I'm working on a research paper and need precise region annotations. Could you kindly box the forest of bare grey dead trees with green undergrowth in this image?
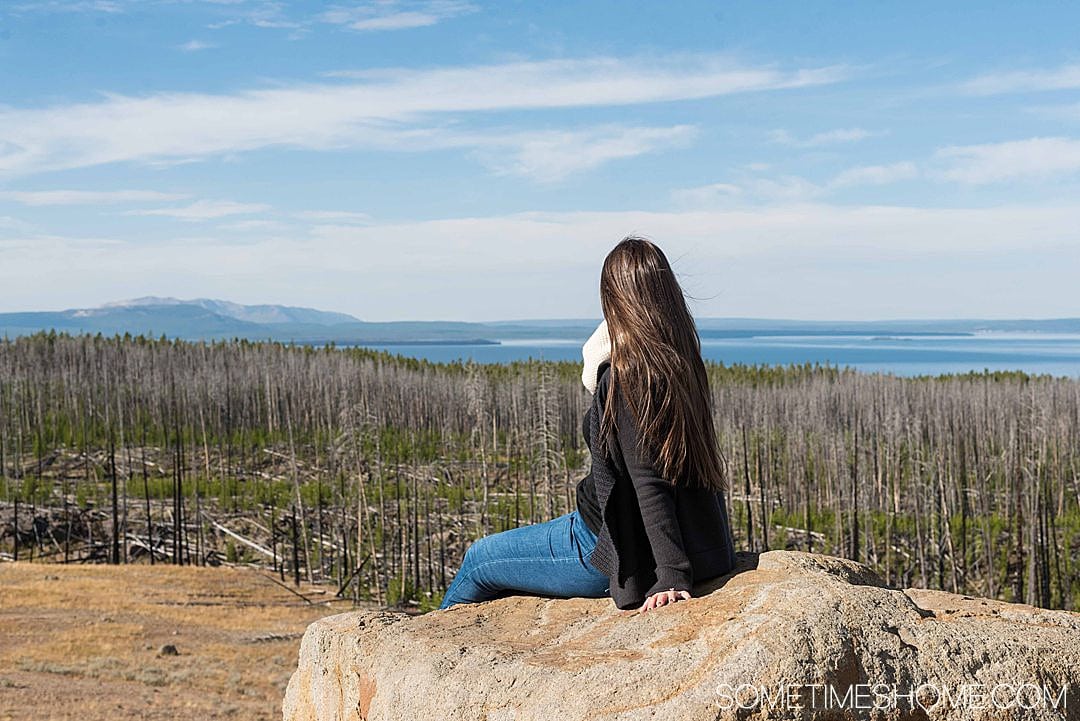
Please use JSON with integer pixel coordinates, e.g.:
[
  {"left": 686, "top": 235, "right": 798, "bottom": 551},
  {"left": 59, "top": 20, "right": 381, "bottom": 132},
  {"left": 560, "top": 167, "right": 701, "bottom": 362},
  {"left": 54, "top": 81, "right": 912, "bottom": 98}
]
[{"left": 0, "top": 332, "right": 1080, "bottom": 612}]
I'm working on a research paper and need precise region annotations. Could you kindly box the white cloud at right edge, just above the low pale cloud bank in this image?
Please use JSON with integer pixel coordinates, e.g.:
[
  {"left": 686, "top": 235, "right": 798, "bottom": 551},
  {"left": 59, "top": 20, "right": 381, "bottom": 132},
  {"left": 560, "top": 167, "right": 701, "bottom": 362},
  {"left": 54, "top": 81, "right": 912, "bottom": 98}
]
[{"left": 935, "top": 137, "right": 1080, "bottom": 185}]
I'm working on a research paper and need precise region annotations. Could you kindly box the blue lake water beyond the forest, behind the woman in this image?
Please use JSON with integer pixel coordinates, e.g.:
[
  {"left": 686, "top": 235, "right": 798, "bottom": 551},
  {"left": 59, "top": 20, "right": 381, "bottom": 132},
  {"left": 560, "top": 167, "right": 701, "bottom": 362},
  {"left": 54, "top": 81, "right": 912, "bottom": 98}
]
[{"left": 358, "top": 332, "right": 1080, "bottom": 378}]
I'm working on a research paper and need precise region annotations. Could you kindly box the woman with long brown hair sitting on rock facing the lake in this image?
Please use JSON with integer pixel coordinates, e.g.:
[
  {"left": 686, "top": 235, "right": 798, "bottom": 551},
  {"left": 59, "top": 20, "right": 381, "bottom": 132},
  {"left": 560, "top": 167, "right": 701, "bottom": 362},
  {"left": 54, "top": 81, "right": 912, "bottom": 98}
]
[{"left": 440, "top": 237, "right": 734, "bottom": 611}]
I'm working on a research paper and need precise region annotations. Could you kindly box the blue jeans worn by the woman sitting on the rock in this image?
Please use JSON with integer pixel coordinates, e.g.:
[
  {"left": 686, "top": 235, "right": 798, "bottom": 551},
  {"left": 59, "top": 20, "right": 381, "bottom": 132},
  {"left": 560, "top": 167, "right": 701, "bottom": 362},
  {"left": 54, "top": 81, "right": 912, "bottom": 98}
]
[{"left": 438, "top": 511, "right": 608, "bottom": 609}]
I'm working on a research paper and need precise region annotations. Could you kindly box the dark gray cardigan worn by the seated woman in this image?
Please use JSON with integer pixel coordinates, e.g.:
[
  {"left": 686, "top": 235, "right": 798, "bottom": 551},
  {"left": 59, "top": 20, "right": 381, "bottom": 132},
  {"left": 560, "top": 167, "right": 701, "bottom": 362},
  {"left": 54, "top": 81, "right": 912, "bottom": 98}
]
[{"left": 589, "top": 361, "right": 735, "bottom": 609}]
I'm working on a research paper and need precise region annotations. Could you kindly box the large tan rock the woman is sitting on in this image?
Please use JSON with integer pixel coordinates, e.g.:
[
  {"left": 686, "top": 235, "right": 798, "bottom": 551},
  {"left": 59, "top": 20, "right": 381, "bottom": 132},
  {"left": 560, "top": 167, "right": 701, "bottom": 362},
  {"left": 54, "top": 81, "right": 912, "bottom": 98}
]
[{"left": 283, "top": 550, "right": 1080, "bottom": 721}]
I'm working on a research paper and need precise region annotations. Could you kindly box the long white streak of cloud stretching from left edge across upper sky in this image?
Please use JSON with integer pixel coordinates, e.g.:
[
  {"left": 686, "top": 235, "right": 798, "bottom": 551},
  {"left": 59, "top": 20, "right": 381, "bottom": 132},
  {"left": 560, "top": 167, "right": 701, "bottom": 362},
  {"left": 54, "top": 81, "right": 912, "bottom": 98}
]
[{"left": 0, "top": 56, "right": 846, "bottom": 174}]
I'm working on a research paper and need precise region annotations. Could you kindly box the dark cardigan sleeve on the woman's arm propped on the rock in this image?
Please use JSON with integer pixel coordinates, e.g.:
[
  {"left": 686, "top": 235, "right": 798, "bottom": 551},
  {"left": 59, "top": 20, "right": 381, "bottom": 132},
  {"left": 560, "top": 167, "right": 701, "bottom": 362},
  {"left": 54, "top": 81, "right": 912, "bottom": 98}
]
[{"left": 616, "top": 382, "right": 693, "bottom": 597}]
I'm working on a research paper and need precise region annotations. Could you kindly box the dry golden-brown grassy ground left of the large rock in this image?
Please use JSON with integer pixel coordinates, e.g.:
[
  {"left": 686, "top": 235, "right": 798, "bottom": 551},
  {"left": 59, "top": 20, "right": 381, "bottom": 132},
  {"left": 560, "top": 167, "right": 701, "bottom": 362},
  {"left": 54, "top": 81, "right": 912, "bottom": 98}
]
[{"left": 0, "top": 562, "right": 367, "bottom": 721}]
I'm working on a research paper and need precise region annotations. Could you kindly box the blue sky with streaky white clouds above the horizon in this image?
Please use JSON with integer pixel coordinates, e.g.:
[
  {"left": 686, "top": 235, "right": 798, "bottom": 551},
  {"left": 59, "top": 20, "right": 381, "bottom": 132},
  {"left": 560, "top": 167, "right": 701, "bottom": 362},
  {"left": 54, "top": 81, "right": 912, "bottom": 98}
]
[{"left": 0, "top": 0, "right": 1080, "bottom": 321}]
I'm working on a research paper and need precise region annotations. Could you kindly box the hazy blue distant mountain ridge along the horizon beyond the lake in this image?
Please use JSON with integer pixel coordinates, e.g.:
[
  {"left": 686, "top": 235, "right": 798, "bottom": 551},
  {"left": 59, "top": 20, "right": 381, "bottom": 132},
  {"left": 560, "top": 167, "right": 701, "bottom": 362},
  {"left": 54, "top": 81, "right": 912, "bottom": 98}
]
[{"left": 0, "top": 296, "right": 1080, "bottom": 345}]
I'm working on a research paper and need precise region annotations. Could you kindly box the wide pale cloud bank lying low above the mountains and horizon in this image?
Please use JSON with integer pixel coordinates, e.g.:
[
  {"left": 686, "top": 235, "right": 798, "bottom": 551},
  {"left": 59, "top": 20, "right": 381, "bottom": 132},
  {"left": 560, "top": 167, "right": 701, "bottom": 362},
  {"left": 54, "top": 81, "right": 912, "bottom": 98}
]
[{"left": 0, "top": 203, "right": 1080, "bottom": 319}]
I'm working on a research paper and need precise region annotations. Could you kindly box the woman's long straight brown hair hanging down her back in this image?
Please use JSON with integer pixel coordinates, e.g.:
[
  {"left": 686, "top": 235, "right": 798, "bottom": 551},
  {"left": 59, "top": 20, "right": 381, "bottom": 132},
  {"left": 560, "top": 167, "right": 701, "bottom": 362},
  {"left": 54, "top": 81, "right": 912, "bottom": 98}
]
[{"left": 600, "top": 236, "right": 727, "bottom": 490}]
